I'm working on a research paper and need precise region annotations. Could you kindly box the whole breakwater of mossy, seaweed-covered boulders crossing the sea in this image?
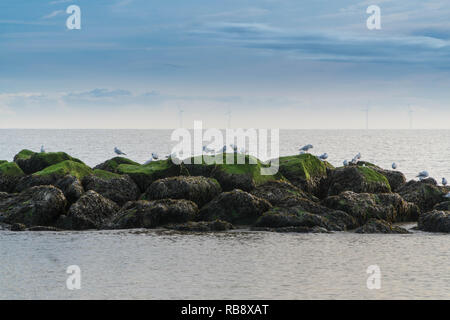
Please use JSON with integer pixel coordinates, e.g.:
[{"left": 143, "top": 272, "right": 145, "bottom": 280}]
[{"left": 0, "top": 150, "right": 450, "bottom": 233}]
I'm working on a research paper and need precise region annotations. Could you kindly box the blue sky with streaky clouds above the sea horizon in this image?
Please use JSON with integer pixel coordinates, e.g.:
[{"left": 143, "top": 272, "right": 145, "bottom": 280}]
[{"left": 0, "top": 0, "right": 450, "bottom": 129}]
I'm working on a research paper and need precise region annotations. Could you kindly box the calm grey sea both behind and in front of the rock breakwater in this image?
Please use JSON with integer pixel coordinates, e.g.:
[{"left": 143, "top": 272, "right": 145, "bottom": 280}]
[{"left": 0, "top": 130, "right": 450, "bottom": 299}]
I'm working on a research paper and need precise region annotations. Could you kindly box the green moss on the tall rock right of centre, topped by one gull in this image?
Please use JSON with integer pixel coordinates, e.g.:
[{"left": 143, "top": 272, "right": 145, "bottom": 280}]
[{"left": 280, "top": 153, "right": 327, "bottom": 180}]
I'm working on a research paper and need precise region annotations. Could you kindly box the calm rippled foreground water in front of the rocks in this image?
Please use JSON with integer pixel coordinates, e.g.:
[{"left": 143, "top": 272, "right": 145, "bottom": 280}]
[{"left": 0, "top": 230, "right": 450, "bottom": 299}]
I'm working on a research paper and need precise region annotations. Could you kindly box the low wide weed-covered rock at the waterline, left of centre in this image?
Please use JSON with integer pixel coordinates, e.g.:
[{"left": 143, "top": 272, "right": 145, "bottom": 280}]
[{"left": 111, "top": 199, "right": 198, "bottom": 229}]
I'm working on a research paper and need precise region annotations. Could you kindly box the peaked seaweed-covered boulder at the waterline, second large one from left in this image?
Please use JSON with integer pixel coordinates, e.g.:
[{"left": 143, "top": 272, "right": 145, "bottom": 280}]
[{"left": 57, "top": 190, "right": 120, "bottom": 230}]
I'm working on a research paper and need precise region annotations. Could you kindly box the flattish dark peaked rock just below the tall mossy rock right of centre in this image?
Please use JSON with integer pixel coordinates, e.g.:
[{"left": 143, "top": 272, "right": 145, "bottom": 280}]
[{"left": 250, "top": 180, "right": 319, "bottom": 206}]
